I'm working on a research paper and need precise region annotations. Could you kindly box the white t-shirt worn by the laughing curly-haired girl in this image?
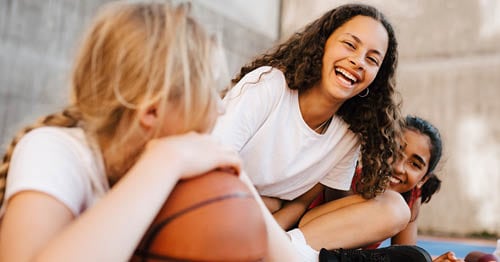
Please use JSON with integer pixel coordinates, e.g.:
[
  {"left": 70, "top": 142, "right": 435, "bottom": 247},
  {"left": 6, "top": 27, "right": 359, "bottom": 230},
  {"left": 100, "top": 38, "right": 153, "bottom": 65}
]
[{"left": 212, "top": 67, "right": 359, "bottom": 200}]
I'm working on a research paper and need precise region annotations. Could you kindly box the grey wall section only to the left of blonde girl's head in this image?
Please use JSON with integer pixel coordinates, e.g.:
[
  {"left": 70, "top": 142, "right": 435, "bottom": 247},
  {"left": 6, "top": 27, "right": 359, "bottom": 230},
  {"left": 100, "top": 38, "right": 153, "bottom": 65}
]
[{"left": 0, "top": 0, "right": 113, "bottom": 152}]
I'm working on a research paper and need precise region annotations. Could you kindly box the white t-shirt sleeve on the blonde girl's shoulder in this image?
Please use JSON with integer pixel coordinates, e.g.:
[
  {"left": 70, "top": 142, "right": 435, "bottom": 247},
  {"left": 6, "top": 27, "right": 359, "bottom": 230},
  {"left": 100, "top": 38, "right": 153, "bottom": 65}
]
[{"left": 4, "top": 128, "right": 89, "bottom": 215}]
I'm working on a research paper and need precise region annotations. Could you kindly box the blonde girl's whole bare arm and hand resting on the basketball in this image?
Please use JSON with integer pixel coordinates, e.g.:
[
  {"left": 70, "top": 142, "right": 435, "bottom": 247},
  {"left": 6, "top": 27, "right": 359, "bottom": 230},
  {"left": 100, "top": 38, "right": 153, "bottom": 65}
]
[{"left": 0, "top": 133, "right": 240, "bottom": 261}]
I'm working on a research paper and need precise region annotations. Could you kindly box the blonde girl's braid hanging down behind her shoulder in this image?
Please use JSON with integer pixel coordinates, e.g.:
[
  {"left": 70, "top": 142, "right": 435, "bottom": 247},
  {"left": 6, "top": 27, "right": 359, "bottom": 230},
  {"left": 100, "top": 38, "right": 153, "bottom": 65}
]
[{"left": 0, "top": 107, "right": 81, "bottom": 207}]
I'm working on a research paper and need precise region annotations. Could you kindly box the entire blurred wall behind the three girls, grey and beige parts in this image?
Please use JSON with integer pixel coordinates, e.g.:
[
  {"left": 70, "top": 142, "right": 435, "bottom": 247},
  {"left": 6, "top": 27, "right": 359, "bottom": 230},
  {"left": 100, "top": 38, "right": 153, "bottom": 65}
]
[{"left": 0, "top": 0, "right": 500, "bottom": 241}]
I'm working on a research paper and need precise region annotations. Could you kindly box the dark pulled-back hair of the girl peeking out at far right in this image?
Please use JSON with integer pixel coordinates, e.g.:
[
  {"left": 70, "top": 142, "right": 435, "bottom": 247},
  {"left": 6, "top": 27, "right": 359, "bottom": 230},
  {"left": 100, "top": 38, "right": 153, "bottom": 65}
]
[{"left": 403, "top": 116, "right": 443, "bottom": 203}]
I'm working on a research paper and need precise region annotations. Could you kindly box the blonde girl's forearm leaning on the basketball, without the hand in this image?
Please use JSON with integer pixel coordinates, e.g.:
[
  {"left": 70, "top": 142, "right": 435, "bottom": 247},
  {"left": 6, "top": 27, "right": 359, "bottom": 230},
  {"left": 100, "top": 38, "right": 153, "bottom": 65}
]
[{"left": 36, "top": 157, "right": 183, "bottom": 261}]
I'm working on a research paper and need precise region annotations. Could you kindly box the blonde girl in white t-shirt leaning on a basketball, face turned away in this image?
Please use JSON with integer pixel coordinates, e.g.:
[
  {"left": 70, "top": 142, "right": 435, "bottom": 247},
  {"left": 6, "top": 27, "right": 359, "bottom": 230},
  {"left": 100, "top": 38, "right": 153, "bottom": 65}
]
[{"left": 0, "top": 3, "right": 244, "bottom": 261}]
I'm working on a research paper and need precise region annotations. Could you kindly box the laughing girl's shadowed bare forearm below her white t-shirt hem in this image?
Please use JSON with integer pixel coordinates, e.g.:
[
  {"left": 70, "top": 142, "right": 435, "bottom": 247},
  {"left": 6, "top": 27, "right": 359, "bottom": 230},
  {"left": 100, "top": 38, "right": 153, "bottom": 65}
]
[{"left": 273, "top": 184, "right": 324, "bottom": 230}]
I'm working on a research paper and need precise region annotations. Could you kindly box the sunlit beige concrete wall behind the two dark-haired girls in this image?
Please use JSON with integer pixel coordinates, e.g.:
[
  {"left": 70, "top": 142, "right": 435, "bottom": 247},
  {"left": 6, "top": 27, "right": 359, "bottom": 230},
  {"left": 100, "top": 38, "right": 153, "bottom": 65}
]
[{"left": 281, "top": 0, "right": 500, "bottom": 235}]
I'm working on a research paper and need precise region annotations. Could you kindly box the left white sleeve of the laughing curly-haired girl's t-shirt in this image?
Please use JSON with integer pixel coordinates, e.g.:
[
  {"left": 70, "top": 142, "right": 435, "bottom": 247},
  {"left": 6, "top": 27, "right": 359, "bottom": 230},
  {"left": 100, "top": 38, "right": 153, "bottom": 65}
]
[{"left": 212, "top": 66, "right": 286, "bottom": 151}]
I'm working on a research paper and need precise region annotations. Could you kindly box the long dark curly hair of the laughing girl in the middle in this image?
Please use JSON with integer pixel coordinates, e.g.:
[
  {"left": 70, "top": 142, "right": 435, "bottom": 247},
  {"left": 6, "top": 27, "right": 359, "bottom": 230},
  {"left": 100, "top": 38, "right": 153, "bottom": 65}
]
[{"left": 232, "top": 4, "right": 401, "bottom": 198}]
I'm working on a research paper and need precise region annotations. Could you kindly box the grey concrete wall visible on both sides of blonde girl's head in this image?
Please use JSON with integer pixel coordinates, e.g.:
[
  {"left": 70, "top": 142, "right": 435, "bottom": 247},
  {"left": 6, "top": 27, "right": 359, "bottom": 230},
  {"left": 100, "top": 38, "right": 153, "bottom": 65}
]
[{"left": 0, "top": 0, "right": 280, "bottom": 153}]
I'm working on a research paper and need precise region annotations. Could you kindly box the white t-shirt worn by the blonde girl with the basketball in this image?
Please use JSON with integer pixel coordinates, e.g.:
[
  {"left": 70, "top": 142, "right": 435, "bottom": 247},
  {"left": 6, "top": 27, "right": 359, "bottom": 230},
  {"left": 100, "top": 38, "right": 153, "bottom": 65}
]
[{"left": 0, "top": 127, "right": 109, "bottom": 216}]
